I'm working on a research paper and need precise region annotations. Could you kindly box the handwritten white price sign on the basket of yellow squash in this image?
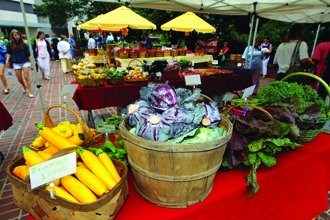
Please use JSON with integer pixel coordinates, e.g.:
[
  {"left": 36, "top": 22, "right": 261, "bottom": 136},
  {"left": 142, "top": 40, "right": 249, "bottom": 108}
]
[{"left": 29, "top": 152, "right": 77, "bottom": 189}]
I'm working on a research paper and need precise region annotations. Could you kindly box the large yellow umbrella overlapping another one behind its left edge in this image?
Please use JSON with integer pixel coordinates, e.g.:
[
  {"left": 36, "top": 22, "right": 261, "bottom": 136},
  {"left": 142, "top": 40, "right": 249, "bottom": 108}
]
[{"left": 89, "top": 6, "right": 156, "bottom": 30}]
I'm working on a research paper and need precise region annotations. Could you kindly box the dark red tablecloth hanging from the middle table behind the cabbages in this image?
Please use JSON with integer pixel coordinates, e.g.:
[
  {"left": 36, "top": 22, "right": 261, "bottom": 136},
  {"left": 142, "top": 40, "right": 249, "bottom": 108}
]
[{"left": 72, "top": 73, "right": 252, "bottom": 110}]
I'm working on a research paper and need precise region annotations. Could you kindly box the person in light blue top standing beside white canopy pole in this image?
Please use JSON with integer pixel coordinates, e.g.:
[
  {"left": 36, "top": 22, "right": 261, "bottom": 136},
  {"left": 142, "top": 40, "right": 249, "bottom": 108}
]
[{"left": 242, "top": 37, "right": 262, "bottom": 95}]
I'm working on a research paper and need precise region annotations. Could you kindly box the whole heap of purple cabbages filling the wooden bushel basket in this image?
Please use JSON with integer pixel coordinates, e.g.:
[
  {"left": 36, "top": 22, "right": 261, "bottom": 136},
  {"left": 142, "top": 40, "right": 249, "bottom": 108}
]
[{"left": 128, "top": 83, "right": 226, "bottom": 143}]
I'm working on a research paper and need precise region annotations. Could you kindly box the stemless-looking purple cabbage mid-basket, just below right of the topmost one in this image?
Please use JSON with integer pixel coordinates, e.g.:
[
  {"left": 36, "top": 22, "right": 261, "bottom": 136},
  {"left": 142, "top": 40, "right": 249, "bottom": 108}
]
[{"left": 162, "top": 107, "right": 195, "bottom": 138}]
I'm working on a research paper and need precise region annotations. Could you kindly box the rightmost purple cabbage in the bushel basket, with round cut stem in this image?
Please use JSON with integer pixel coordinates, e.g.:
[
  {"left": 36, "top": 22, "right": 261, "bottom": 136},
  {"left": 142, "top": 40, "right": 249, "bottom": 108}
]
[{"left": 194, "top": 102, "right": 221, "bottom": 128}]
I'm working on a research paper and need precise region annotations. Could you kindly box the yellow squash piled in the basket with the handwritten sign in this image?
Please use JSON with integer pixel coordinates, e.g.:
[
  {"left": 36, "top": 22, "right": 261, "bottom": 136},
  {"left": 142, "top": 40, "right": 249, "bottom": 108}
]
[{"left": 13, "top": 121, "right": 127, "bottom": 203}]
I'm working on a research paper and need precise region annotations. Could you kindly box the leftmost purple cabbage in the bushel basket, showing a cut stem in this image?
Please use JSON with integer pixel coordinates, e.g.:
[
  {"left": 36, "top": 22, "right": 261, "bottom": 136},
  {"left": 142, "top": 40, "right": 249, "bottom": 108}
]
[{"left": 127, "top": 99, "right": 155, "bottom": 127}]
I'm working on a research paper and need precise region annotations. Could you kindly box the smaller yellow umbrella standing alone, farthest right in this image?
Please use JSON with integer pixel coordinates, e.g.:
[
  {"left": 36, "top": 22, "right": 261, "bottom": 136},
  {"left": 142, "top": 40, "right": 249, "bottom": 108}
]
[{"left": 160, "top": 12, "right": 215, "bottom": 33}]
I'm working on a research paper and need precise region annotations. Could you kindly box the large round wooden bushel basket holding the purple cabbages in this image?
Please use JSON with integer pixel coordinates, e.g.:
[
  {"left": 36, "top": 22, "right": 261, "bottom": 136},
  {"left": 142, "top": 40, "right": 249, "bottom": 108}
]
[{"left": 120, "top": 117, "right": 233, "bottom": 208}]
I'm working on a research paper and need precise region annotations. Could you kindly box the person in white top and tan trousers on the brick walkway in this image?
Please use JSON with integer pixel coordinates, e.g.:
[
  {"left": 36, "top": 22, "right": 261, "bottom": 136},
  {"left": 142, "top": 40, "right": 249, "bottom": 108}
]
[{"left": 57, "top": 35, "right": 72, "bottom": 74}]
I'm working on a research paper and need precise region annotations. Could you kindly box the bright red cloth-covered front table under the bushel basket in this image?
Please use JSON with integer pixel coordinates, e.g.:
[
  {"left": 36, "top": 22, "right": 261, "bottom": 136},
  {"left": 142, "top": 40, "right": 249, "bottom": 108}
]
[{"left": 116, "top": 133, "right": 330, "bottom": 220}]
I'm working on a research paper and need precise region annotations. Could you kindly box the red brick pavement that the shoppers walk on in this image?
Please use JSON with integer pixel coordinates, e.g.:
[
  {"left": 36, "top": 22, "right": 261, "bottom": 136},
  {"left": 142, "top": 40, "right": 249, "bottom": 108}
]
[{"left": 0, "top": 61, "right": 330, "bottom": 220}]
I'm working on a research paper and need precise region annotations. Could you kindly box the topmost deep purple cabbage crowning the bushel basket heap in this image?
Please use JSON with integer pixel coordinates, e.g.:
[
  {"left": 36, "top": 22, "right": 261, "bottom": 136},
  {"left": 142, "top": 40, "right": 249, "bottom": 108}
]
[{"left": 140, "top": 83, "right": 177, "bottom": 112}]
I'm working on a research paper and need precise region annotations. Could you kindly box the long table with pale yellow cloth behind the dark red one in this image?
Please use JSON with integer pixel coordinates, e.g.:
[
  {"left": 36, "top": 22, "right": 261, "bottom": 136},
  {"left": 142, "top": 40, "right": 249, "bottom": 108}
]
[{"left": 116, "top": 55, "right": 213, "bottom": 68}]
